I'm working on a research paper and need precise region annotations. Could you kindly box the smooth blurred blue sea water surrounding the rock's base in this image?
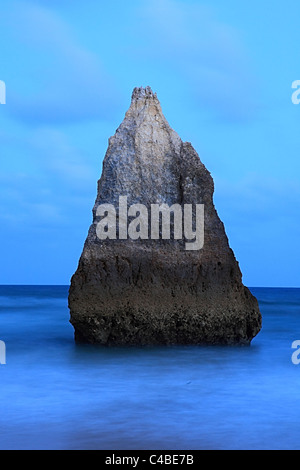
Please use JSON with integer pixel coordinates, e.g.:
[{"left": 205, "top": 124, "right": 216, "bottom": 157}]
[{"left": 0, "top": 286, "right": 300, "bottom": 450}]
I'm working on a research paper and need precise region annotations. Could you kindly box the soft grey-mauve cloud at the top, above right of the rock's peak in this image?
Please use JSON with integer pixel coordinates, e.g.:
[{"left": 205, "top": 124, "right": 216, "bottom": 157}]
[{"left": 141, "top": 0, "right": 259, "bottom": 120}]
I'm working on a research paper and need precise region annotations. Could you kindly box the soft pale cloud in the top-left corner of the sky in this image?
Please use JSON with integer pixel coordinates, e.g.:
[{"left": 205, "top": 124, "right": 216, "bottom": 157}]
[{"left": 4, "top": 2, "right": 117, "bottom": 123}]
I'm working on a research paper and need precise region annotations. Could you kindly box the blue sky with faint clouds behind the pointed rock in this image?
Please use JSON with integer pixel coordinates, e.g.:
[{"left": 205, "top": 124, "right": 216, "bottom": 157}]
[{"left": 0, "top": 0, "right": 300, "bottom": 287}]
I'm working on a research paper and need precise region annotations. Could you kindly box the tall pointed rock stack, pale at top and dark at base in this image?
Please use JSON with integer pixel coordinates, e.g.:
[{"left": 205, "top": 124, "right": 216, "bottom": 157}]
[{"left": 69, "top": 87, "right": 261, "bottom": 345}]
